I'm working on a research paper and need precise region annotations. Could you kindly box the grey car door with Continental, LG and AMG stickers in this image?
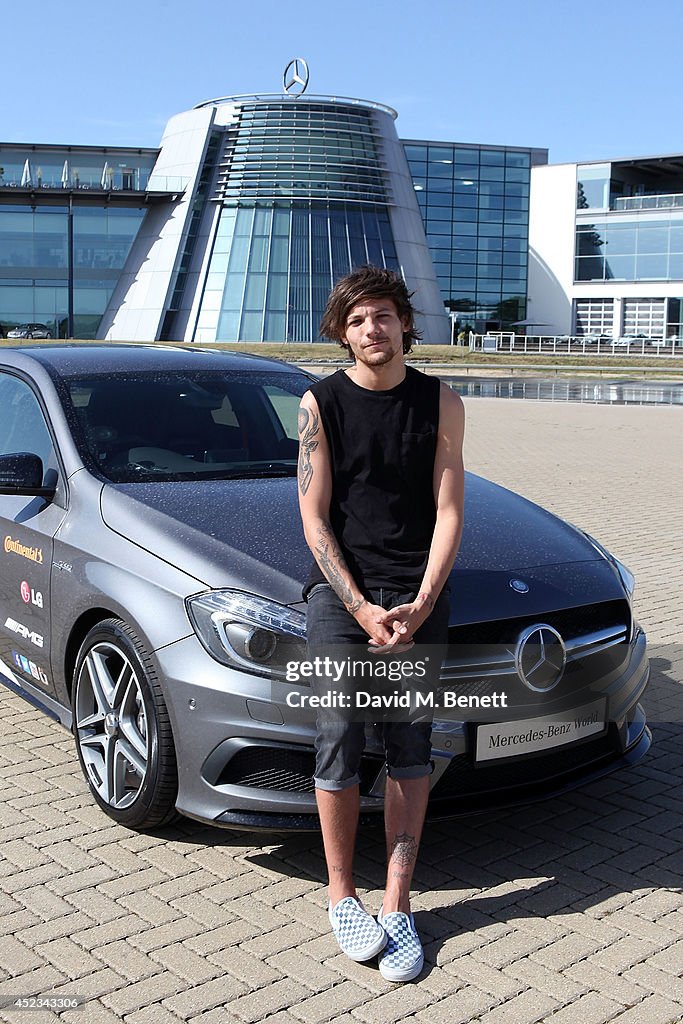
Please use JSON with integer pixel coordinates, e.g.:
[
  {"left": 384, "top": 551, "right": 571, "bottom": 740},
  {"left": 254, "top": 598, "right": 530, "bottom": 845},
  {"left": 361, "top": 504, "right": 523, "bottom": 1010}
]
[{"left": 0, "top": 368, "right": 65, "bottom": 693}]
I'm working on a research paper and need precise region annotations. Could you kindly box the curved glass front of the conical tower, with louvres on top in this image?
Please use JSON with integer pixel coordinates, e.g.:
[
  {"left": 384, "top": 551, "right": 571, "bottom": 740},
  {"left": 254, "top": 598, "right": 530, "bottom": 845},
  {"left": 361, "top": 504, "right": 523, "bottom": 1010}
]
[{"left": 198, "top": 99, "right": 398, "bottom": 342}]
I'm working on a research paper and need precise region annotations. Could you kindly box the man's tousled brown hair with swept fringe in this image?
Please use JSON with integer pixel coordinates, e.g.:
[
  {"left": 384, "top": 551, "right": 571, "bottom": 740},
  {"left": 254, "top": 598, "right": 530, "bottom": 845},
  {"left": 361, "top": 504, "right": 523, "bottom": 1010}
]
[{"left": 321, "top": 266, "right": 422, "bottom": 353}]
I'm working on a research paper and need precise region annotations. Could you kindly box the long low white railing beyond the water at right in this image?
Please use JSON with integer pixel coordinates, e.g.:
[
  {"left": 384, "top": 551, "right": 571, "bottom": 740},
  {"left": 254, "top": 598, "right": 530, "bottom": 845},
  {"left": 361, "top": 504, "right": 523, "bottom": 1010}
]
[{"left": 470, "top": 331, "right": 683, "bottom": 357}]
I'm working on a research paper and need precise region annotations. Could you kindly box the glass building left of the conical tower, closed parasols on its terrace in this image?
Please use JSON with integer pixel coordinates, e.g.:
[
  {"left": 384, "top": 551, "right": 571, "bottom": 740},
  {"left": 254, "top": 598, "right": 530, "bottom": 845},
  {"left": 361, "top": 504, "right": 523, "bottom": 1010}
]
[{"left": 0, "top": 143, "right": 158, "bottom": 338}]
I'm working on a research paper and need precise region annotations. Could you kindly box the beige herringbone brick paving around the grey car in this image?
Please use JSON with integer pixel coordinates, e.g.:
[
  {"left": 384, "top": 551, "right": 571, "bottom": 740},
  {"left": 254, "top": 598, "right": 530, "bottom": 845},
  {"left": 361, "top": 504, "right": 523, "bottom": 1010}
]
[{"left": 0, "top": 399, "right": 683, "bottom": 1024}]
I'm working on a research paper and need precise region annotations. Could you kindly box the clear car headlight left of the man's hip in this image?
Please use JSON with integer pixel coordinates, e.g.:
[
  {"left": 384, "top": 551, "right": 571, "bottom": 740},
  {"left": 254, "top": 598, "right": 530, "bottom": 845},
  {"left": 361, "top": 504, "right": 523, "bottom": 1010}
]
[{"left": 186, "top": 590, "right": 306, "bottom": 679}]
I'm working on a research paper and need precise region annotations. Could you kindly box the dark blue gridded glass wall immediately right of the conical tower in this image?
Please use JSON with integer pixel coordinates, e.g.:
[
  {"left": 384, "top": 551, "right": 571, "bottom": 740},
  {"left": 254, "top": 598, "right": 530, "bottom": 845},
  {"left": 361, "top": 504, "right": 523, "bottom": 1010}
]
[{"left": 403, "top": 141, "right": 543, "bottom": 330}]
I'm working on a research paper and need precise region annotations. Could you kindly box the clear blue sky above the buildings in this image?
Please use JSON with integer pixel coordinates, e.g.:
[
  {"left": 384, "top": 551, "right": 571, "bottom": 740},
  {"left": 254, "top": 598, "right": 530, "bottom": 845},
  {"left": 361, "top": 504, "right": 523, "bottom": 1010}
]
[{"left": 5, "top": 0, "right": 683, "bottom": 163}]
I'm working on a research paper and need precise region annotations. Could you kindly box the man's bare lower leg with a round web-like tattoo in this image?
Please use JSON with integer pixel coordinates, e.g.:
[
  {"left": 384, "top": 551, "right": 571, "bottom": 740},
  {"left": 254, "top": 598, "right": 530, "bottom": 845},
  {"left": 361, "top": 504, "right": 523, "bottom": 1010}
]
[{"left": 382, "top": 775, "right": 429, "bottom": 914}]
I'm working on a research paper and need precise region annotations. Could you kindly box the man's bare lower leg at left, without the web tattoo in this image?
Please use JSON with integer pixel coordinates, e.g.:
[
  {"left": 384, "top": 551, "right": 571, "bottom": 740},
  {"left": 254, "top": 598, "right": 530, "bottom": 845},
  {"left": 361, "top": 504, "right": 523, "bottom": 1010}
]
[{"left": 315, "top": 785, "right": 359, "bottom": 906}]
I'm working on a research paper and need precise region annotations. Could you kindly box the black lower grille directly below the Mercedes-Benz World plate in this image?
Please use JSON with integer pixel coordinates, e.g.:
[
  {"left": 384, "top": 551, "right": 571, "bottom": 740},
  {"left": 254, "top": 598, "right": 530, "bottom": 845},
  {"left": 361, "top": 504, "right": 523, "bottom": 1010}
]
[{"left": 431, "top": 725, "right": 621, "bottom": 801}]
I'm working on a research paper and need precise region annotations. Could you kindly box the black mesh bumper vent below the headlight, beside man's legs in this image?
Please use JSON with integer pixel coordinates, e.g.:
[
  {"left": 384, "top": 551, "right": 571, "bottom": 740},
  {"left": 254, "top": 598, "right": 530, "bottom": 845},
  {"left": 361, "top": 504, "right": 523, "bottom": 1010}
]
[{"left": 217, "top": 743, "right": 384, "bottom": 794}]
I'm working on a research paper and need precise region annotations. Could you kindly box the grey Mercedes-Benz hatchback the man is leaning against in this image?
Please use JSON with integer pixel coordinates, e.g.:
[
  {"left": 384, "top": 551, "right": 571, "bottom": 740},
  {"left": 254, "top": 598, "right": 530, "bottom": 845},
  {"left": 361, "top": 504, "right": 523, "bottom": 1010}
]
[{"left": 0, "top": 344, "right": 650, "bottom": 830}]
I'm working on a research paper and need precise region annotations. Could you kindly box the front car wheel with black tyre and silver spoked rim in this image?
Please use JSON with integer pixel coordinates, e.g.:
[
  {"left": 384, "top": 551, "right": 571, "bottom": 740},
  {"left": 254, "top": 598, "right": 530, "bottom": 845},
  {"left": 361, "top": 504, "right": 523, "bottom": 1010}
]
[{"left": 72, "top": 618, "right": 178, "bottom": 829}]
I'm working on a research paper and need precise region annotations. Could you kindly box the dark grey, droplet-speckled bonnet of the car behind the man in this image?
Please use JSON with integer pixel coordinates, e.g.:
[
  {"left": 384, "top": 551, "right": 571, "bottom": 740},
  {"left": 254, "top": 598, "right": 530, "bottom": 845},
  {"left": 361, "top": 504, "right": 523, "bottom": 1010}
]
[{"left": 101, "top": 473, "right": 623, "bottom": 621}]
